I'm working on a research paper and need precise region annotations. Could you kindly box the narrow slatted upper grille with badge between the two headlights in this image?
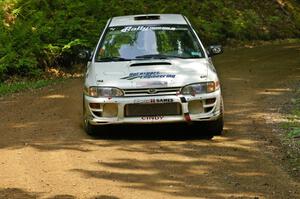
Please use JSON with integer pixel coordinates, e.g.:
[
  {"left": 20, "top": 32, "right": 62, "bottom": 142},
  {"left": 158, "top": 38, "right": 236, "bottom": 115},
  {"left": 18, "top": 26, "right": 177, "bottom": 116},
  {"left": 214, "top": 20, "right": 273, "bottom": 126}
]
[{"left": 123, "top": 87, "right": 180, "bottom": 97}]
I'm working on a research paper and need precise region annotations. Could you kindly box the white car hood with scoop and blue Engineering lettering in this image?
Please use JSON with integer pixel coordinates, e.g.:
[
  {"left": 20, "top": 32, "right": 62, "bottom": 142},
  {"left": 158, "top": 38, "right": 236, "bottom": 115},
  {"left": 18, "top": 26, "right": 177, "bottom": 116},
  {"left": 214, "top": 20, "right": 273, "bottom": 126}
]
[{"left": 93, "top": 59, "right": 210, "bottom": 89}]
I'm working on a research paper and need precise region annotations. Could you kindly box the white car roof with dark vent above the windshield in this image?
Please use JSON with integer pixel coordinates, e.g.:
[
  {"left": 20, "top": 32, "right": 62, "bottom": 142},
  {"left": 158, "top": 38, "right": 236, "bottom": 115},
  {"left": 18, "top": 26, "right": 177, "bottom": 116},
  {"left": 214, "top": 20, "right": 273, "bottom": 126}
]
[{"left": 109, "top": 14, "right": 187, "bottom": 27}]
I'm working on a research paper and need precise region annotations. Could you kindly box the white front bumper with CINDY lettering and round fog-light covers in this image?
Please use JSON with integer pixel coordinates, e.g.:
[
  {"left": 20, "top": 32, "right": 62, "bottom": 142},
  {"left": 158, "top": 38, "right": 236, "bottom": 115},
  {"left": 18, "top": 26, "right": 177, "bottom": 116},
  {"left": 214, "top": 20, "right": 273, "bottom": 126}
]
[{"left": 83, "top": 90, "right": 222, "bottom": 125}]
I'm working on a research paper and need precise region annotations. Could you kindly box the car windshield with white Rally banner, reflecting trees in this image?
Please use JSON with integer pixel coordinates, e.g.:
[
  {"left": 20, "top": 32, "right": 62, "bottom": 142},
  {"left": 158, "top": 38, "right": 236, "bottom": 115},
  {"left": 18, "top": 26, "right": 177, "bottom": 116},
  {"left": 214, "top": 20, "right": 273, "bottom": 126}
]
[{"left": 96, "top": 25, "right": 204, "bottom": 62}]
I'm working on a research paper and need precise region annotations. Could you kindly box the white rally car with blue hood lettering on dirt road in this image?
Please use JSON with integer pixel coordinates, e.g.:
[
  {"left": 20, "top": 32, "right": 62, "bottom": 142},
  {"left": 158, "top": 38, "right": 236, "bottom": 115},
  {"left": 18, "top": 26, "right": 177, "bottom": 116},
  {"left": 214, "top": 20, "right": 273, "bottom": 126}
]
[{"left": 80, "top": 14, "right": 223, "bottom": 135}]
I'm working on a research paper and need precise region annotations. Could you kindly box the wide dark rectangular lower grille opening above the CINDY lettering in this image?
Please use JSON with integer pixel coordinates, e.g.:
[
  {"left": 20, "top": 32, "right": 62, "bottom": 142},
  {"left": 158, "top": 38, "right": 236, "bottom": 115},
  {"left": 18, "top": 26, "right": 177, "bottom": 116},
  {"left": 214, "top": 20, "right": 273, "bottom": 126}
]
[{"left": 124, "top": 103, "right": 182, "bottom": 117}]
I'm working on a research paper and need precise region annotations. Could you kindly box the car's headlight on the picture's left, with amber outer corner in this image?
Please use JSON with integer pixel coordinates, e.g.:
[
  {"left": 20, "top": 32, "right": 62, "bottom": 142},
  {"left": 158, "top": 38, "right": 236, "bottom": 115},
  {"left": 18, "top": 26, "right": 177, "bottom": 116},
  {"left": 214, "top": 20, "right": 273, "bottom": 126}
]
[{"left": 86, "top": 86, "right": 124, "bottom": 97}]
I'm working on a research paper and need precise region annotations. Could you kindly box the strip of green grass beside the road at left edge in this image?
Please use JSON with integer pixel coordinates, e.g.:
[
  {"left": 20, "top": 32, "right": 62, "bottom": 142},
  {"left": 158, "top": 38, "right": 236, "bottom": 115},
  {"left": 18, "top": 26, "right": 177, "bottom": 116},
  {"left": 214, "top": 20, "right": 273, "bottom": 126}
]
[{"left": 0, "top": 78, "right": 66, "bottom": 96}]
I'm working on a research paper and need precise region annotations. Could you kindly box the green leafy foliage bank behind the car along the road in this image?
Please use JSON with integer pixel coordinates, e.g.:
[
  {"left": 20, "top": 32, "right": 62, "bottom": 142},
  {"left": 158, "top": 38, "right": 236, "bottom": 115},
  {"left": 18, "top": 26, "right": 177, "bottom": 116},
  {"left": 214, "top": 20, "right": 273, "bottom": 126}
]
[{"left": 0, "top": 0, "right": 300, "bottom": 82}]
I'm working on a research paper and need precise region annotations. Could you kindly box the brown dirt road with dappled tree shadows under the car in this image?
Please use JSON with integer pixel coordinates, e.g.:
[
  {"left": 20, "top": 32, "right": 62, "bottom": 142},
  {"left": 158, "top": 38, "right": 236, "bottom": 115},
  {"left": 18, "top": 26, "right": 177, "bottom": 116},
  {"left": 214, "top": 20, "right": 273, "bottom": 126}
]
[{"left": 0, "top": 44, "right": 300, "bottom": 199}]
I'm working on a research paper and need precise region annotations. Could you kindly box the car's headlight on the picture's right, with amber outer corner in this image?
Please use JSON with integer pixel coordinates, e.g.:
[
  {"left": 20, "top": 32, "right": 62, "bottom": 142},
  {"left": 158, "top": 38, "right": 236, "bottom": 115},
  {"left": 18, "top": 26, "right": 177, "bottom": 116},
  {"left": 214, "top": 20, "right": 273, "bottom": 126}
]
[{"left": 181, "top": 81, "right": 220, "bottom": 95}]
